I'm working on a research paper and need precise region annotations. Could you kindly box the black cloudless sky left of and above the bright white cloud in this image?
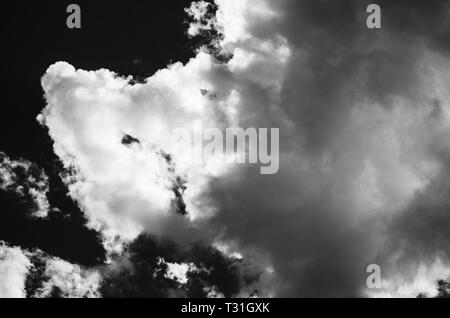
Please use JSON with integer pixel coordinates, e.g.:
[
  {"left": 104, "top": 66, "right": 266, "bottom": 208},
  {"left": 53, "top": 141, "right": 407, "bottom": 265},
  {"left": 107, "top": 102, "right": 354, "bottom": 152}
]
[{"left": 0, "top": 0, "right": 194, "bottom": 265}]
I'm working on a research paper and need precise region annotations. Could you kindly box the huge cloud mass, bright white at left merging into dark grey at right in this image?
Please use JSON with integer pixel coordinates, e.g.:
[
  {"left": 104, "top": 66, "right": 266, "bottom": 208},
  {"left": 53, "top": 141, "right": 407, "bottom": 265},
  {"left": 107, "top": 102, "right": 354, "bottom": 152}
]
[{"left": 39, "top": 0, "right": 450, "bottom": 296}]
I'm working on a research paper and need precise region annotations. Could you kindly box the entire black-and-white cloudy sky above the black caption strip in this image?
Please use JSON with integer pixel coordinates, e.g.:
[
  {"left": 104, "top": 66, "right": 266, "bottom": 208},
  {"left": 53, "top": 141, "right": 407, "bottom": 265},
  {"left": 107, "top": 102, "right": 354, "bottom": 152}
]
[{"left": 0, "top": 0, "right": 450, "bottom": 297}]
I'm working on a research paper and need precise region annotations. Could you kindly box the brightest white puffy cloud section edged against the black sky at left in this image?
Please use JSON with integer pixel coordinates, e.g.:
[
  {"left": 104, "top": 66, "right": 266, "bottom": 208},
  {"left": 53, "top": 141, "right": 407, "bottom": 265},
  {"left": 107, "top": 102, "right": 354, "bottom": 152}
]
[{"left": 42, "top": 54, "right": 234, "bottom": 246}]
